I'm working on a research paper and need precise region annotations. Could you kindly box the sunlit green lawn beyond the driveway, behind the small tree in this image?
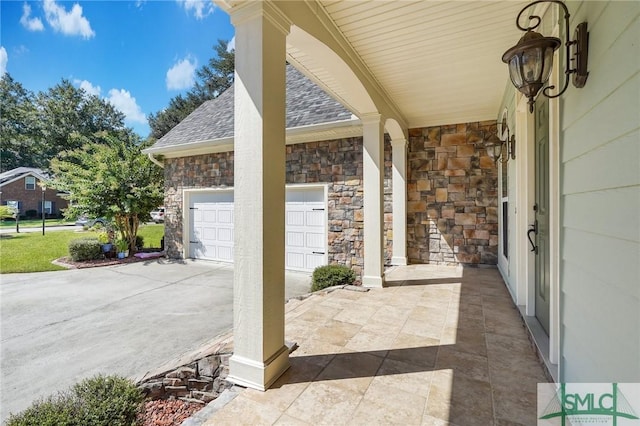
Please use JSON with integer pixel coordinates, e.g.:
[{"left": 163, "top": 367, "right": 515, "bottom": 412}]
[{"left": 0, "top": 224, "right": 164, "bottom": 274}]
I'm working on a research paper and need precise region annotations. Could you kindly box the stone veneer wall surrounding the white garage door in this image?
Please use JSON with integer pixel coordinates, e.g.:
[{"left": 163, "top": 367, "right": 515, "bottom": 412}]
[{"left": 165, "top": 138, "right": 392, "bottom": 276}]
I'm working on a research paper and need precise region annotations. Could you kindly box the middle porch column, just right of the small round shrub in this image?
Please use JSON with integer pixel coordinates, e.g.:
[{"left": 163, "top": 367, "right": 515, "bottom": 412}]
[{"left": 360, "top": 114, "right": 384, "bottom": 287}]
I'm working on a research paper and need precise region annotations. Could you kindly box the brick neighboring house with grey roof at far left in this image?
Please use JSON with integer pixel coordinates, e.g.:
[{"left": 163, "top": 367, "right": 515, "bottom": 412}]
[{"left": 0, "top": 167, "right": 69, "bottom": 217}]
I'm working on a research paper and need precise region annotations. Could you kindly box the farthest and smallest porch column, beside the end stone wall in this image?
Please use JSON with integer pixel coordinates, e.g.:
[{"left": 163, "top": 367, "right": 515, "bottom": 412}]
[{"left": 391, "top": 139, "right": 407, "bottom": 265}]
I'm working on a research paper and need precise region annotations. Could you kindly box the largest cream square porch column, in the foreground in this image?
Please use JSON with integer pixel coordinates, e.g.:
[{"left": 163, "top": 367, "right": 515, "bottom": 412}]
[{"left": 227, "top": 2, "right": 290, "bottom": 390}]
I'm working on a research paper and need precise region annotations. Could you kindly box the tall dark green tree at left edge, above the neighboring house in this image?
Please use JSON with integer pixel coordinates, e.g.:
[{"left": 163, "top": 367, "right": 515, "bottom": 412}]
[{"left": 0, "top": 73, "right": 42, "bottom": 172}]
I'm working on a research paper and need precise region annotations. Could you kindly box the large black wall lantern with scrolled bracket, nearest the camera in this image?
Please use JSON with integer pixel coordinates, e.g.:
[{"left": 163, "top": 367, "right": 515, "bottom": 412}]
[{"left": 502, "top": 0, "right": 589, "bottom": 112}]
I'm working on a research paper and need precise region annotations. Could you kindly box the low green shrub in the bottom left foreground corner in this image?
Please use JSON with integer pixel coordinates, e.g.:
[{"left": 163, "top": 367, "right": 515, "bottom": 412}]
[{"left": 7, "top": 376, "right": 144, "bottom": 426}]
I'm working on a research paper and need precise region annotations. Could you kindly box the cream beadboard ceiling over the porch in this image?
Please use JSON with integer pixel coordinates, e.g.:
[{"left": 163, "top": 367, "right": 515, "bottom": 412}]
[{"left": 300, "top": 0, "right": 528, "bottom": 127}]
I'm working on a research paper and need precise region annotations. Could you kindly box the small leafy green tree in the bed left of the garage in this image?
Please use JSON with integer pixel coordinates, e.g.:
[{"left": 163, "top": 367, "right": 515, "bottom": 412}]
[{"left": 50, "top": 131, "right": 164, "bottom": 255}]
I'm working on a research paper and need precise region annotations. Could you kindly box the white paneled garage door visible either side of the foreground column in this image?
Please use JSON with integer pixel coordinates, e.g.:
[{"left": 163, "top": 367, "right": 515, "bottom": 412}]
[{"left": 189, "top": 188, "right": 327, "bottom": 272}]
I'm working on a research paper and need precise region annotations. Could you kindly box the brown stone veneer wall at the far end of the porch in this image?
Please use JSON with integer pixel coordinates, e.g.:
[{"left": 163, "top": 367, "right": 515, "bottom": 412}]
[{"left": 407, "top": 121, "right": 498, "bottom": 265}]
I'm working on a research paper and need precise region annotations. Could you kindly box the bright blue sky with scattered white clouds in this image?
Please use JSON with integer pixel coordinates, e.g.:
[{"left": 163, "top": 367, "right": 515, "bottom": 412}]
[{"left": 0, "top": 0, "right": 234, "bottom": 137}]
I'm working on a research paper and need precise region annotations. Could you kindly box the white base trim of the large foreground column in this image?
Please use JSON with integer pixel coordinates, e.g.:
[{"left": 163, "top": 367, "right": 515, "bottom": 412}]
[{"left": 226, "top": 346, "right": 291, "bottom": 392}]
